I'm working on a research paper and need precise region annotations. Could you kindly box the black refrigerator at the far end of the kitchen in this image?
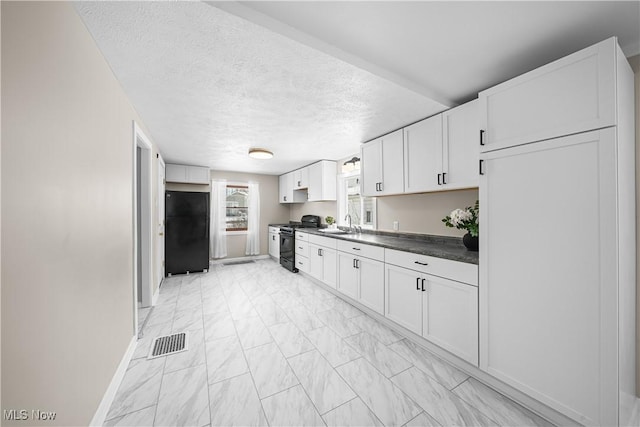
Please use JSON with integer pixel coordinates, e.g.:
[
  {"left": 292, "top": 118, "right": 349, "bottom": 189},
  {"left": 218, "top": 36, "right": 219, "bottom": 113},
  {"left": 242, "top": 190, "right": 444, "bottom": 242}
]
[{"left": 164, "top": 191, "right": 209, "bottom": 276}]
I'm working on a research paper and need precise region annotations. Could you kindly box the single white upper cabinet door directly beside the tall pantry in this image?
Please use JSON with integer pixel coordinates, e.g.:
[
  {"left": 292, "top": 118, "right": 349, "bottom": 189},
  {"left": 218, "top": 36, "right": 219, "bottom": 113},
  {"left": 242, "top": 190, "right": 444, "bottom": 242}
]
[{"left": 439, "top": 99, "right": 480, "bottom": 190}]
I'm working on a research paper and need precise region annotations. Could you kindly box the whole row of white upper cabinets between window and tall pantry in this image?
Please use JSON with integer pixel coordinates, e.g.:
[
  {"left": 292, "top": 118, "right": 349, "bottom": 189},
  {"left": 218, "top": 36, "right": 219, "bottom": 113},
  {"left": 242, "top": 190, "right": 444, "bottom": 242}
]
[{"left": 361, "top": 100, "right": 480, "bottom": 196}]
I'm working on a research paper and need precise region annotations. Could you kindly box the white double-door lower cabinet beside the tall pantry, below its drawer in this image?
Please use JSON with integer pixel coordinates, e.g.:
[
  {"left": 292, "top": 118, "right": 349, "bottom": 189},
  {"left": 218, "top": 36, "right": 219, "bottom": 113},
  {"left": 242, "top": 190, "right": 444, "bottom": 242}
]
[{"left": 384, "top": 260, "right": 478, "bottom": 366}]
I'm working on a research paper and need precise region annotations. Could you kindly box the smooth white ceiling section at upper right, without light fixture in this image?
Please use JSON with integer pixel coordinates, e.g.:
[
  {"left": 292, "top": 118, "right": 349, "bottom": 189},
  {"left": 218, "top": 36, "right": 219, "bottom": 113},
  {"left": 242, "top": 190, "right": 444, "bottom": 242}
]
[{"left": 236, "top": 1, "right": 640, "bottom": 105}]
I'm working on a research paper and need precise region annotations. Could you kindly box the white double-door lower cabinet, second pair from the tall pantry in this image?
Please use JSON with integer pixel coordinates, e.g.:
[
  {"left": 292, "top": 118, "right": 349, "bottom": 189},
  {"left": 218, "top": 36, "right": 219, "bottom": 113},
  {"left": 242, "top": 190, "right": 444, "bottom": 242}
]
[{"left": 337, "top": 252, "right": 384, "bottom": 314}]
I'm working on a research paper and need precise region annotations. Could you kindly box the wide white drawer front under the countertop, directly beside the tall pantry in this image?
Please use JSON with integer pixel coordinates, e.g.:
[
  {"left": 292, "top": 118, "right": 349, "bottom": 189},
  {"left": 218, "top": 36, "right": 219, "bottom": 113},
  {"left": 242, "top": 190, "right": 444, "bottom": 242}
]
[{"left": 384, "top": 249, "right": 478, "bottom": 286}]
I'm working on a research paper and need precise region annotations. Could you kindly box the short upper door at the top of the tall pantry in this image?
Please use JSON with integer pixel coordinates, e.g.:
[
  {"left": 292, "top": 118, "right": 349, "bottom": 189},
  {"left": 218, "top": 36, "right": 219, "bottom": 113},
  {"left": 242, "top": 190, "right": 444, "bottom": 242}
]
[{"left": 478, "top": 38, "right": 616, "bottom": 152}]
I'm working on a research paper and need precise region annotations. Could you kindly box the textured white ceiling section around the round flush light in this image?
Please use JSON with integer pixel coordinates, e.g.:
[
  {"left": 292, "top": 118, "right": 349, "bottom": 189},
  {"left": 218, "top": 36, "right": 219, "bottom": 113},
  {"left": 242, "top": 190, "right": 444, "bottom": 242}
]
[{"left": 75, "top": 2, "right": 446, "bottom": 174}]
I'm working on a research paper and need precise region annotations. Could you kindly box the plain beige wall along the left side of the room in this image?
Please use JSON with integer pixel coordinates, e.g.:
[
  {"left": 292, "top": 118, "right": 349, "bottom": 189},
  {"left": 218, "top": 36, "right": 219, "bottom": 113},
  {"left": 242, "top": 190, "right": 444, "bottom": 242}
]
[{"left": 1, "top": 2, "right": 156, "bottom": 426}]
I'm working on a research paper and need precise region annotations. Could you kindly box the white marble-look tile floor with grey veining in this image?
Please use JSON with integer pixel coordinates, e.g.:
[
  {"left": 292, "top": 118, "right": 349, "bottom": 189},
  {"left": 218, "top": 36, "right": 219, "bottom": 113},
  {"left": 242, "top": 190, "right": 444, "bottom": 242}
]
[{"left": 105, "top": 260, "right": 551, "bottom": 427}]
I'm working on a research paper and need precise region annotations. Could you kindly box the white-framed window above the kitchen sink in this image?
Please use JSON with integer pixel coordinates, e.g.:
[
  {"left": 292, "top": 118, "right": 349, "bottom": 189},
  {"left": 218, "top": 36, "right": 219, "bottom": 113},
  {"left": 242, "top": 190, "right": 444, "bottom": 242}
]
[{"left": 338, "top": 173, "right": 376, "bottom": 229}]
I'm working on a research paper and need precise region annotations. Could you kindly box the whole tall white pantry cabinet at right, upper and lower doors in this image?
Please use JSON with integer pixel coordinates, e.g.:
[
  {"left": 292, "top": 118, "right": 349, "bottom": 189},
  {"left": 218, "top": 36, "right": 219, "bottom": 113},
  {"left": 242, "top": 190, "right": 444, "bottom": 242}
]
[{"left": 479, "top": 38, "right": 636, "bottom": 426}]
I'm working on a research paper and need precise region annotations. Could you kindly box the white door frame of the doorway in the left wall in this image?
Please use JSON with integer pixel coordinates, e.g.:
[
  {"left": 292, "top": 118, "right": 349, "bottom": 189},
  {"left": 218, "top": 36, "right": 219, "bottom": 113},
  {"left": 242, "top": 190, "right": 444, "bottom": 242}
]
[{"left": 132, "top": 120, "right": 153, "bottom": 336}]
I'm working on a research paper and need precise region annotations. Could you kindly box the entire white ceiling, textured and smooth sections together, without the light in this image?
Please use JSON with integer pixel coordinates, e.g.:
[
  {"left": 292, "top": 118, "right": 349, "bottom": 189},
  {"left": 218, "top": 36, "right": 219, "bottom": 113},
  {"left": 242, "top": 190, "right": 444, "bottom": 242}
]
[{"left": 74, "top": 1, "right": 640, "bottom": 174}]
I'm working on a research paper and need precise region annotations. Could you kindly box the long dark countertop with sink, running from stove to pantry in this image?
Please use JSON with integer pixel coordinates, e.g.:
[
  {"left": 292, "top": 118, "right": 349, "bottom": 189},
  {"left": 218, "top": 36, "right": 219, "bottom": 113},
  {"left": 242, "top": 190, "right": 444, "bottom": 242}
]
[{"left": 304, "top": 228, "right": 478, "bottom": 265}]
